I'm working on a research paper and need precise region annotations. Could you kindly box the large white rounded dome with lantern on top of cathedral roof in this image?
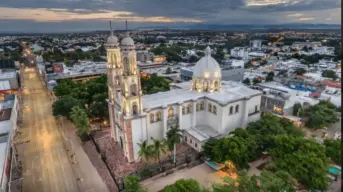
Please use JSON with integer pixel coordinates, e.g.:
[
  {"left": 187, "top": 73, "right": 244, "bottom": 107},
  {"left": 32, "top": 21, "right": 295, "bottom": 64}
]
[{"left": 193, "top": 47, "right": 221, "bottom": 79}]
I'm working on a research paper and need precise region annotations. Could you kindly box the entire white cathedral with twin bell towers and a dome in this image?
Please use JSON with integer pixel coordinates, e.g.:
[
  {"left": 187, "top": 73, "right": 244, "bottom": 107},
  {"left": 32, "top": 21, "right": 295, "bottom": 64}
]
[{"left": 105, "top": 32, "right": 262, "bottom": 162}]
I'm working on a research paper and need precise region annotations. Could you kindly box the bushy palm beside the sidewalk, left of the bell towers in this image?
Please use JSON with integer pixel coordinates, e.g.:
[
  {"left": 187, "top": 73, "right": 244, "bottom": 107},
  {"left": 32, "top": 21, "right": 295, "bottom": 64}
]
[{"left": 70, "top": 106, "right": 90, "bottom": 135}]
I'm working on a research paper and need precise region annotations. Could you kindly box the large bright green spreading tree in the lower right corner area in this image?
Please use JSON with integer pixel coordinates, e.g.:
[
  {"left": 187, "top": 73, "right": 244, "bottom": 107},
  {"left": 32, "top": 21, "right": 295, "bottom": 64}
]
[{"left": 269, "top": 135, "right": 329, "bottom": 190}]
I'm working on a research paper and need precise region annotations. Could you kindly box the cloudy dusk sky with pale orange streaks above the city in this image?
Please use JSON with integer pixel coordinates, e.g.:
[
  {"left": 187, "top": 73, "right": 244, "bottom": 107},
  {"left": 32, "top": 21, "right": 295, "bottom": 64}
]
[{"left": 0, "top": 0, "right": 341, "bottom": 32}]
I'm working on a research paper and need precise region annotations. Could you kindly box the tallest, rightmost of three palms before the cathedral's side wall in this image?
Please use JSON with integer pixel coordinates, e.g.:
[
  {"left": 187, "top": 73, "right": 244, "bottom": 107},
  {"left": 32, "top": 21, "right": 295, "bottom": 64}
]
[{"left": 166, "top": 125, "right": 182, "bottom": 165}]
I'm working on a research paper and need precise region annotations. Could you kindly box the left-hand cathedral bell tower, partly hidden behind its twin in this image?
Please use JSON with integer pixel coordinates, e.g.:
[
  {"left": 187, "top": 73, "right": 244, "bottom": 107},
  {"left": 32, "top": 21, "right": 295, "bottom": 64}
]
[{"left": 104, "top": 21, "right": 122, "bottom": 140}]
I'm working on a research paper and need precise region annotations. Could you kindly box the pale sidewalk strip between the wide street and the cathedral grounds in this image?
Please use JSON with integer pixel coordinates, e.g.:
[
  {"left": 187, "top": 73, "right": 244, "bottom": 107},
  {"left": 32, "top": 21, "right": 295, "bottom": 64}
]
[{"left": 61, "top": 120, "right": 109, "bottom": 192}]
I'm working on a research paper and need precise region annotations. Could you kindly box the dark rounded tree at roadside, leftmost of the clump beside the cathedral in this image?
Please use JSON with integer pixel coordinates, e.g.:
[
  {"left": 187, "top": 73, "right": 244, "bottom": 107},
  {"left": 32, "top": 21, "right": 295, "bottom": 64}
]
[{"left": 52, "top": 96, "right": 80, "bottom": 118}]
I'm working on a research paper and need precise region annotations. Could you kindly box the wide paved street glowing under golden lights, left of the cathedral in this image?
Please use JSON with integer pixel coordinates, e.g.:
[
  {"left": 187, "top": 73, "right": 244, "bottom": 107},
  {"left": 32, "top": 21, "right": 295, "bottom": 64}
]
[{"left": 17, "top": 67, "right": 79, "bottom": 192}]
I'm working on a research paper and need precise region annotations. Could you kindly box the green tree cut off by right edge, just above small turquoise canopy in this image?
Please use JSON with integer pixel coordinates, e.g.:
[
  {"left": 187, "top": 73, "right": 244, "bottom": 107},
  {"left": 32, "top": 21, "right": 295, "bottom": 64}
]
[{"left": 324, "top": 139, "right": 342, "bottom": 165}]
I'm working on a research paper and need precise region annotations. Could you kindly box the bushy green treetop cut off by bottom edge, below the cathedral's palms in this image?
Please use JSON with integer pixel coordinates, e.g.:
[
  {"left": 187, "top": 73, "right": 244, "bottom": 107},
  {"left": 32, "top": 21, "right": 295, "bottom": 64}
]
[{"left": 161, "top": 179, "right": 202, "bottom": 192}]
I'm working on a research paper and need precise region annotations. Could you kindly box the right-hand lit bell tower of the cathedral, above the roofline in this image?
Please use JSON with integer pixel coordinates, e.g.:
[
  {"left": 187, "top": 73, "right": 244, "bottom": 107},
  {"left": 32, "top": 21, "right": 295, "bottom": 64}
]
[{"left": 121, "top": 23, "right": 143, "bottom": 117}]
